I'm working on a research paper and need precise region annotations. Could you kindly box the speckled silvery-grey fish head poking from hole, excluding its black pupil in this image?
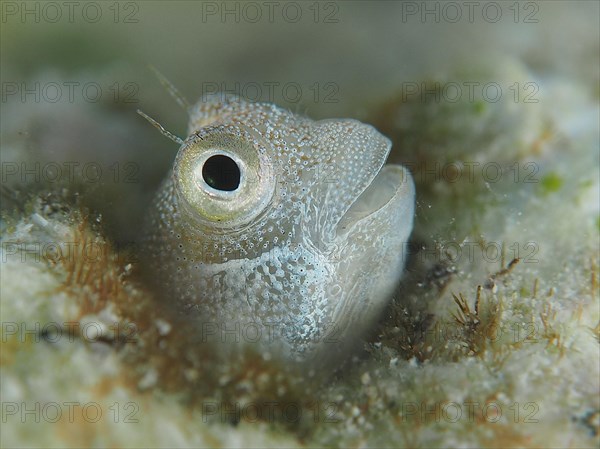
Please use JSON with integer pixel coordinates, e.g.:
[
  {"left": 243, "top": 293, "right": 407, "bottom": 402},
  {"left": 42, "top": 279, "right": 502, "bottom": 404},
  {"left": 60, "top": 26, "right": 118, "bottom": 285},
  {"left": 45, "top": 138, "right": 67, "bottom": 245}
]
[{"left": 144, "top": 94, "right": 415, "bottom": 360}]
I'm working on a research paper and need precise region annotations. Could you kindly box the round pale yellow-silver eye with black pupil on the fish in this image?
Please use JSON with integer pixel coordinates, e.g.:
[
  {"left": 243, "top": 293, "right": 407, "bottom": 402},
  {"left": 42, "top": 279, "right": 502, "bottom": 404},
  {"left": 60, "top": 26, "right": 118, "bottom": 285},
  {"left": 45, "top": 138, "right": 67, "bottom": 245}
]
[{"left": 173, "top": 126, "right": 275, "bottom": 228}]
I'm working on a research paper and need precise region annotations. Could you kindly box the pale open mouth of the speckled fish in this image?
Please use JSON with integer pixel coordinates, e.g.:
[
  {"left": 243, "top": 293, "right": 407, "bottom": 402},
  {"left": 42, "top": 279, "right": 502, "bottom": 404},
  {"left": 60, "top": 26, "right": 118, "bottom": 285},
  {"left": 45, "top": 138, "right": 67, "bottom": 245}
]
[{"left": 337, "top": 164, "right": 414, "bottom": 236}]
